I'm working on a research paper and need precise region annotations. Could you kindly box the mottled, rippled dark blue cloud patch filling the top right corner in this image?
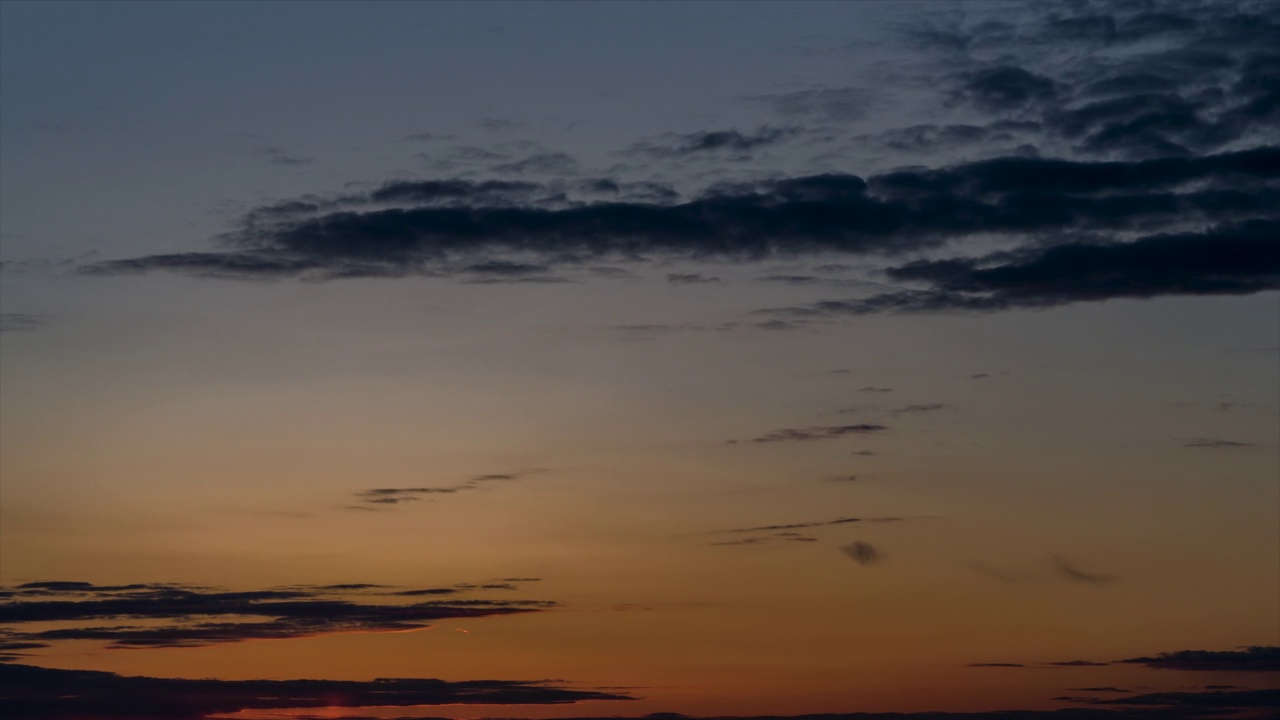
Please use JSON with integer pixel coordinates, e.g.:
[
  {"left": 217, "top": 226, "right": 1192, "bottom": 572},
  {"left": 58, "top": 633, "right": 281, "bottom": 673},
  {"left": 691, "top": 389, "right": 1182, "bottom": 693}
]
[{"left": 916, "top": 3, "right": 1280, "bottom": 158}]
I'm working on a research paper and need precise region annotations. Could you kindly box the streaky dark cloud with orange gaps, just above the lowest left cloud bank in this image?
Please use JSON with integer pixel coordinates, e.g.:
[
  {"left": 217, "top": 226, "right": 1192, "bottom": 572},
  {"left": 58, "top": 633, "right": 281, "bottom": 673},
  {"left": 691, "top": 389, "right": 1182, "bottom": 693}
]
[{"left": 0, "top": 582, "right": 556, "bottom": 653}]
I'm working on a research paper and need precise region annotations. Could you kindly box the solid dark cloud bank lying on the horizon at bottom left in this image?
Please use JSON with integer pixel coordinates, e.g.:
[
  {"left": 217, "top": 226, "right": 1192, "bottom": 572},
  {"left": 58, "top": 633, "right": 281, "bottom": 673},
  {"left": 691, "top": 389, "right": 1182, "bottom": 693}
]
[{"left": 0, "top": 664, "right": 631, "bottom": 720}]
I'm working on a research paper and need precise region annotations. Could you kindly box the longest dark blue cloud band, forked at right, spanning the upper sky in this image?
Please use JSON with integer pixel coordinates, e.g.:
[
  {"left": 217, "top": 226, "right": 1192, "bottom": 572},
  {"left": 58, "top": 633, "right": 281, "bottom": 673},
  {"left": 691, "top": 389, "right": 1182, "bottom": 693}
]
[{"left": 84, "top": 140, "right": 1280, "bottom": 299}]
